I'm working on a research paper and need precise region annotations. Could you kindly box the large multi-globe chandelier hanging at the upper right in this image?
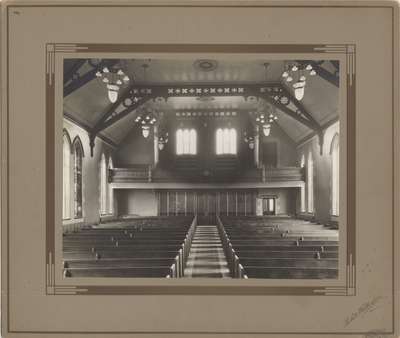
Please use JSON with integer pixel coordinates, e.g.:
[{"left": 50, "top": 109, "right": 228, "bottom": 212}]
[{"left": 282, "top": 62, "right": 317, "bottom": 101}]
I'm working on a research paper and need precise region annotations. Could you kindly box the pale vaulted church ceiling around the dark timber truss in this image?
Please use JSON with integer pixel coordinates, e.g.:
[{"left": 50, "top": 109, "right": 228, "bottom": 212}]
[{"left": 64, "top": 58, "right": 339, "bottom": 145}]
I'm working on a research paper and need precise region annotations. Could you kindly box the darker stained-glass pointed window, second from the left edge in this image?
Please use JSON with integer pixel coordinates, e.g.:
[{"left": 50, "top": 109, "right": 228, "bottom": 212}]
[{"left": 73, "top": 137, "right": 83, "bottom": 218}]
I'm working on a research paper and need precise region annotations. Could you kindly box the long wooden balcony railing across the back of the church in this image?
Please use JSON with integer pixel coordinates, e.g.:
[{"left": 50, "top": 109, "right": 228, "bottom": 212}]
[{"left": 109, "top": 165, "right": 304, "bottom": 183}]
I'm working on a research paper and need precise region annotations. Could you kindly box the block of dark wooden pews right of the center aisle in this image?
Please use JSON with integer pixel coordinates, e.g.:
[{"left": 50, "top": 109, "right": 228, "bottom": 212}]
[{"left": 218, "top": 217, "right": 338, "bottom": 279}]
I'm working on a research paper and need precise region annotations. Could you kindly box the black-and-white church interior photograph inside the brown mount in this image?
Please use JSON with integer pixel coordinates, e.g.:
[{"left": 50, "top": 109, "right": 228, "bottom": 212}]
[{"left": 59, "top": 55, "right": 340, "bottom": 280}]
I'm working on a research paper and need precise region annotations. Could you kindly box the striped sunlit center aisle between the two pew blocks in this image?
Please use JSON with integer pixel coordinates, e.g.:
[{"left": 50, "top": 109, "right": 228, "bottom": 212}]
[{"left": 184, "top": 225, "right": 230, "bottom": 278}]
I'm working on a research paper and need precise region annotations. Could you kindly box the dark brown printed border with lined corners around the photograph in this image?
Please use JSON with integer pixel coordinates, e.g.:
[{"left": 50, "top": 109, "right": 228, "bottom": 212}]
[{"left": 45, "top": 43, "right": 356, "bottom": 296}]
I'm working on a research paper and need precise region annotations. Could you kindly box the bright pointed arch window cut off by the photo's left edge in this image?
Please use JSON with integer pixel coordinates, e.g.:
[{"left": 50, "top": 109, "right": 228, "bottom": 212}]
[{"left": 63, "top": 131, "right": 72, "bottom": 219}]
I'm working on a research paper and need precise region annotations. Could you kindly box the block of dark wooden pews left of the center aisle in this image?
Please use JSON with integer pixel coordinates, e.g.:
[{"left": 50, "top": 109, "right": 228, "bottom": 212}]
[{"left": 63, "top": 216, "right": 196, "bottom": 278}]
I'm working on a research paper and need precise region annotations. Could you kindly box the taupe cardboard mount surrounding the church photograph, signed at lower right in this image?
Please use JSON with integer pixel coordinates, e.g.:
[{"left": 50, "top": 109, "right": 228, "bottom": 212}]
[{"left": 1, "top": 1, "right": 400, "bottom": 337}]
